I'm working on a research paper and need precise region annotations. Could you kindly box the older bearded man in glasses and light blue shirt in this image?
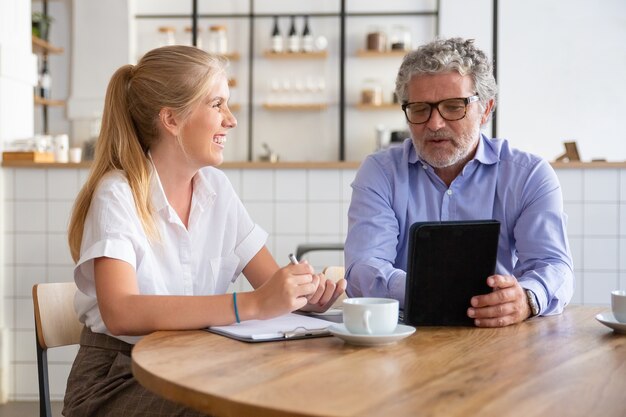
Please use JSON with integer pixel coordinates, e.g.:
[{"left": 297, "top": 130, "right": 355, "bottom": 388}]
[{"left": 345, "top": 38, "right": 574, "bottom": 327}]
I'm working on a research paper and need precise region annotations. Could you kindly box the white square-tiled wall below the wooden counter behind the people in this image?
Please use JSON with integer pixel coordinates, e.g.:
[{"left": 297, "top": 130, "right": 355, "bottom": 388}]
[{"left": 0, "top": 168, "right": 626, "bottom": 400}]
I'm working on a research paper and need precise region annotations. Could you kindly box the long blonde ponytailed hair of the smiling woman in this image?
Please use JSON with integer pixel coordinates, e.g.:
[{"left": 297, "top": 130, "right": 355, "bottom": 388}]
[{"left": 68, "top": 45, "right": 227, "bottom": 262}]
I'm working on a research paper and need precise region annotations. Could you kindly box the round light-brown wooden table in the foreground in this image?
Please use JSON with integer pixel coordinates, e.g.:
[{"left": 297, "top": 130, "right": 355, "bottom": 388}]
[{"left": 132, "top": 306, "right": 626, "bottom": 417}]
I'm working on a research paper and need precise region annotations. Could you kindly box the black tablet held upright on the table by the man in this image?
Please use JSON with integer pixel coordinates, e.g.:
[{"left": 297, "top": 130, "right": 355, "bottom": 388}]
[{"left": 404, "top": 220, "right": 500, "bottom": 326}]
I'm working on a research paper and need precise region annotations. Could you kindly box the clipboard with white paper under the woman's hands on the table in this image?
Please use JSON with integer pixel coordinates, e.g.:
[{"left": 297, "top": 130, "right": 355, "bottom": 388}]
[{"left": 207, "top": 313, "right": 333, "bottom": 342}]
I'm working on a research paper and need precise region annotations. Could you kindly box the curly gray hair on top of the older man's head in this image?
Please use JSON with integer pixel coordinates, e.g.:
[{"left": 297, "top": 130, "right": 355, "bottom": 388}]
[{"left": 396, "top": 38, "right": 498, "bottom": 111}]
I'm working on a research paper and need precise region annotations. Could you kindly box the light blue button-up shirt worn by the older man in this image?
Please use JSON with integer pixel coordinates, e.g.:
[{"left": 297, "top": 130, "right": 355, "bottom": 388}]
[{"left": 345, "top": 135, "right": 574, "bottom": 315}]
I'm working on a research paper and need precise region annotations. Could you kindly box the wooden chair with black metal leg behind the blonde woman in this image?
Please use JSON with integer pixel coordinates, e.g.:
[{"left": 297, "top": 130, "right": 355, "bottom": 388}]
[{"left": 33, "top": 282, "right": 83, "bottom": 417}]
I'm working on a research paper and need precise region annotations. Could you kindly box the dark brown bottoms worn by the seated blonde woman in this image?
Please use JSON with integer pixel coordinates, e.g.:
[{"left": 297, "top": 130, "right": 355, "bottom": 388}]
[{"left": 63, "top": 328, "right": 205, "bottom": 417}]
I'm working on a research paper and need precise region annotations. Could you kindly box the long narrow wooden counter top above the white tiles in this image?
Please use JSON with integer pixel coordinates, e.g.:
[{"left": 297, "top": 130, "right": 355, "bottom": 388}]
[{"left": 2, "top": 161, "right": 626, "bottom": 169}]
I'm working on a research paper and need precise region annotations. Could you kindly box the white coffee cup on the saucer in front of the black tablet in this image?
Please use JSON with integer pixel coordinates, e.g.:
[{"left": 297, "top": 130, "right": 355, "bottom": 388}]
[{"left": 343, "top": 297, "right": 399, "bottom": 335}]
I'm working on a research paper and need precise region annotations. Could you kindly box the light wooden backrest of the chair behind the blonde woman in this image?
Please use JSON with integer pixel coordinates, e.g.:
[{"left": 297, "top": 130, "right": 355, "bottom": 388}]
[{"left": 33, "top": 282, "right": 83, "bottom": 349}]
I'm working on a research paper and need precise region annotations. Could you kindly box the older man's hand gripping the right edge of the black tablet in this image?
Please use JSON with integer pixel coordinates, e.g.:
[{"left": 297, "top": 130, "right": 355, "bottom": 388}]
[{"left": 467, "top": 275, "right": 531, "bottom": 327}]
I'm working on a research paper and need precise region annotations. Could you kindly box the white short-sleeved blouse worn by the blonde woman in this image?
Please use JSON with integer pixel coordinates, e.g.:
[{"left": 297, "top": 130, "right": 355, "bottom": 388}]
[{"left": 74, "top": 167, "right": 267, "bottom": 343}]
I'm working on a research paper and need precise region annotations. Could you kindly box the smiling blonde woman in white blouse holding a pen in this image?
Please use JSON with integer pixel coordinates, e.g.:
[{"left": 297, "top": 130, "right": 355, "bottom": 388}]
[{"left": 64, "top": 46, "right": 345, "bottom": 416}]
